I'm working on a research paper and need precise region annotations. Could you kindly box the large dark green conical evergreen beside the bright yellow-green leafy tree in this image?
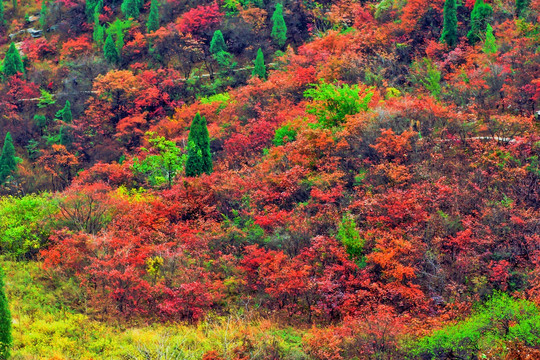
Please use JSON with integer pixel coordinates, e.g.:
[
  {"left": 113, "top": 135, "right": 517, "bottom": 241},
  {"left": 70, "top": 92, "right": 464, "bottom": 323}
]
[{"left": 186, "top": 113, "right": 212, "bottom": 176}]
